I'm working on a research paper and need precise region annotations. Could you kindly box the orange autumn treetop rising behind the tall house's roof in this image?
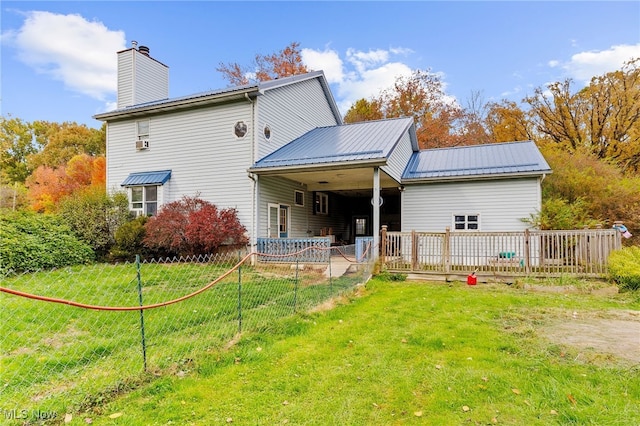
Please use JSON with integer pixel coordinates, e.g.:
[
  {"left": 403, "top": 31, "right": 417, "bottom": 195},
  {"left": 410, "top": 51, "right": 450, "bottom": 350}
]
[{"left": 216, "top": 42, "right": 310, "bottom": 86}]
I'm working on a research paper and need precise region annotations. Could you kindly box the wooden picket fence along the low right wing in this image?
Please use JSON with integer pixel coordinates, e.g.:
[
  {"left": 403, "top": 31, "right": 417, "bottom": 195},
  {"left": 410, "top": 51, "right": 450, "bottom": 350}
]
[{"left": 380, "top": 227, "right": 622, "bottom": 279}]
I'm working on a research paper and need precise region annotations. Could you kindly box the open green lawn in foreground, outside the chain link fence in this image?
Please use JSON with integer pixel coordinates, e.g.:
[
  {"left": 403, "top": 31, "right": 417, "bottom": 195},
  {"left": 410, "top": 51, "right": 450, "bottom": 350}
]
[{"left": 62, "top": 279, "right": 640, "bottom": 425}]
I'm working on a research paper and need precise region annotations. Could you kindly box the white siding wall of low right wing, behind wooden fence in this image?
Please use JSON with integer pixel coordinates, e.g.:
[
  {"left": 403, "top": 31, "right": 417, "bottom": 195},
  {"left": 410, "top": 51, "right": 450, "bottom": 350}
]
[{"left": 401, "top": 177, "right": 541, "bottom": 232}]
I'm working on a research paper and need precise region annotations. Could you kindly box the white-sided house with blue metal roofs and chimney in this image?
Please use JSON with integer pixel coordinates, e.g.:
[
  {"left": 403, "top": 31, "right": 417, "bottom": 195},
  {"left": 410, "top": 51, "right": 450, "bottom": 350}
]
[{"left": 95, "top": 45, "right": 551, "bottom": 250}]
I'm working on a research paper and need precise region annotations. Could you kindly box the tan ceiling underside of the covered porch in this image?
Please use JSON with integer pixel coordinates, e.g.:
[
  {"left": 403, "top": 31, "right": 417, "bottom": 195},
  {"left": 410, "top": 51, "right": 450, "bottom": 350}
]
[{"left": 271, "top": 167, "right": 400, "bottom": 196}]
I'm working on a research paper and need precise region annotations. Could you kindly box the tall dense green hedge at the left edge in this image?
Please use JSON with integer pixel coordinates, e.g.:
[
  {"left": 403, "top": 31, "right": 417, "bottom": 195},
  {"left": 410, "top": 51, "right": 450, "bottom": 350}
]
[{"left": 0, "top": 212, "right": 94, "bottom": 275}]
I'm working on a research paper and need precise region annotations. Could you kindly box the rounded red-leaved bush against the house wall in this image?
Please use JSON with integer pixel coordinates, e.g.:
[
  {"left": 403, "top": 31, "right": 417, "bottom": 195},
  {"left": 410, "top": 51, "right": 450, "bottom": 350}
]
[{"left": 143, "top": 196, "right": 249, "bottom": 256}]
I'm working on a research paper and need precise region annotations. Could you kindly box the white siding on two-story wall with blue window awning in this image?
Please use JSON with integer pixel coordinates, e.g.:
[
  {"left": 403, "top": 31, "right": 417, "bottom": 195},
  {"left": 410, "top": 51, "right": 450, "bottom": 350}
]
[{"left": 107, "top": 102, "right": 253, "bottom": 238}]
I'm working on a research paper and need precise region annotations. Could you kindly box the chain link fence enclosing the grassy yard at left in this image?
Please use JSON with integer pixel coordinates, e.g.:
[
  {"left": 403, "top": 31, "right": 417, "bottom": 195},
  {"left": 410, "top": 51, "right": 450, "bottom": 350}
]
[{"left": 0, "top": 246, "right": 372, "bottom": 417}]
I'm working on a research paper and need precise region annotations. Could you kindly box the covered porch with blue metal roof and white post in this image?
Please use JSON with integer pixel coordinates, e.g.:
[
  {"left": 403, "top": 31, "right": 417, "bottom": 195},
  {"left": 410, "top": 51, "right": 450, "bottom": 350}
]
[{"left": 249, "top": 118, "right": 417, "bottom": 255}]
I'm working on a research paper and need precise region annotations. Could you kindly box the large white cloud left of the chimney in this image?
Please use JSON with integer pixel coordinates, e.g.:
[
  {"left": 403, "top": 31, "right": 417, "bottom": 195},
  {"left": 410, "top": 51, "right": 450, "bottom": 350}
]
[{"left": 2, "top": 11, "right": 125, "bottom": 100}]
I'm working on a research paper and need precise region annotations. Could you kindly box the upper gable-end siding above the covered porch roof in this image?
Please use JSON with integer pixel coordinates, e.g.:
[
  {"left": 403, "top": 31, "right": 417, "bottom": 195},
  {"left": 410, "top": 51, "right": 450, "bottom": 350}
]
[{"left": 256, "top": 78, "right": 337, "bottom": 161}]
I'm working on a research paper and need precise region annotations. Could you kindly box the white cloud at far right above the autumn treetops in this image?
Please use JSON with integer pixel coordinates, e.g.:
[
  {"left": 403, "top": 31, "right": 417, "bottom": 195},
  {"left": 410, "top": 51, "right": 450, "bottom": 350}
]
[{"left": 550, "top": 43, "right": 640, "bottom": 84}]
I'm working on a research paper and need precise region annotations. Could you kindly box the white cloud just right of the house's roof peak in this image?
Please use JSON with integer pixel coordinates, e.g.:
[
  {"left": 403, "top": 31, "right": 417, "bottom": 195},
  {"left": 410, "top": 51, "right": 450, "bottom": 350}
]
[{"left": 302, "top": 48, "right": 412, "bottom": 114}]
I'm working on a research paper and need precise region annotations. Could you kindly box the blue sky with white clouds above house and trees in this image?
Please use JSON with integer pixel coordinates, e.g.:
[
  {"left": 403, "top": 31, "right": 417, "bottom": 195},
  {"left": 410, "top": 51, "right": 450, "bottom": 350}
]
[{"left": 0, "top": 0, "right": 640, "bottom": 127}]
